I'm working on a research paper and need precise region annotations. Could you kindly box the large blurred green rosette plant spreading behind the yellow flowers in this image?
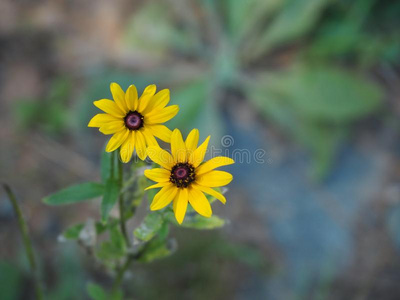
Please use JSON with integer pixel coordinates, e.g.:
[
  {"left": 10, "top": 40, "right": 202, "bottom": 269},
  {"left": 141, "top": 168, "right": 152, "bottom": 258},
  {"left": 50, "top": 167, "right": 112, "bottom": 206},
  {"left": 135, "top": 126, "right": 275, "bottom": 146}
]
[{"left": 77, "top": 0, "right": 400, "bottom": 179}]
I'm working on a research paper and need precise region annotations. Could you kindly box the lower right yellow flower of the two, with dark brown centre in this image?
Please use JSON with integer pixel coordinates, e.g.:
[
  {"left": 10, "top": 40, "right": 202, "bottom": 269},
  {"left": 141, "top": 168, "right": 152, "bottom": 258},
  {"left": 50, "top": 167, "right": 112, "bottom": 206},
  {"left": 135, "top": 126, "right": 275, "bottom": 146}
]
[{"left": 144, "top": 129, "right": 234, "bottom": 224}]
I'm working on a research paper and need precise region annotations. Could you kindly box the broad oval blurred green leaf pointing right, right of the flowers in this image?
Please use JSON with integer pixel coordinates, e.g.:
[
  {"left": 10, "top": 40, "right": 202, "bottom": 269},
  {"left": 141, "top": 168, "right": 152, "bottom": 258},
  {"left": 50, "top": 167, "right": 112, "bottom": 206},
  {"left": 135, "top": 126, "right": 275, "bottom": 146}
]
[{"left": 267, "top": 66, "right": 383, "bottom": 123}]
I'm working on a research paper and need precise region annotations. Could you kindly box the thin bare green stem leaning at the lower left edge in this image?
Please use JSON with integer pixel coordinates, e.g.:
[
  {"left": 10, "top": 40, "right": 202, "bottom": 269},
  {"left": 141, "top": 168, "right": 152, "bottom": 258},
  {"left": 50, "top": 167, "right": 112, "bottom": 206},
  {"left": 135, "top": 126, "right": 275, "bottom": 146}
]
[{"left": 3, "top": 184, "right": 43, "bottom": 300}]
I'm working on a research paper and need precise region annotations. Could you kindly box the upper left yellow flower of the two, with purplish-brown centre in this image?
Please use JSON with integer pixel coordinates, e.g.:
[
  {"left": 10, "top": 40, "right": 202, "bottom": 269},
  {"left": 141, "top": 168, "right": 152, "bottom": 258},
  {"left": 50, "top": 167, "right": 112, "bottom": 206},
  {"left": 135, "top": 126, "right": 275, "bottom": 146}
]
[{"left": 88, "top": 83, "right": 179, "bottom": 163}]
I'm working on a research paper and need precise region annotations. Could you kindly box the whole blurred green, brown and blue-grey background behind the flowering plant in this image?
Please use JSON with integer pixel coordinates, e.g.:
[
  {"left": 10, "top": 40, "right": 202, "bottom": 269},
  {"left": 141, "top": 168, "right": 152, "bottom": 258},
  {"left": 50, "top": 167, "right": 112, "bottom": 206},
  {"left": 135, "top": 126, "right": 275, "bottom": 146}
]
[{"left": 0, "top": 0, "right": 400, "bottom": 300}]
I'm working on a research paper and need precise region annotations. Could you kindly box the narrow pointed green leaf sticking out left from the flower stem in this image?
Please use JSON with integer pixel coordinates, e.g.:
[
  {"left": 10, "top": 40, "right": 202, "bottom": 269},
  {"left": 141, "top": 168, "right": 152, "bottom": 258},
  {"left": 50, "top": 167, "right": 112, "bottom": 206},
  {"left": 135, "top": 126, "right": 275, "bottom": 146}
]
[{"left": 43, "top": 182, "right": 104, "bottom": 205}]
